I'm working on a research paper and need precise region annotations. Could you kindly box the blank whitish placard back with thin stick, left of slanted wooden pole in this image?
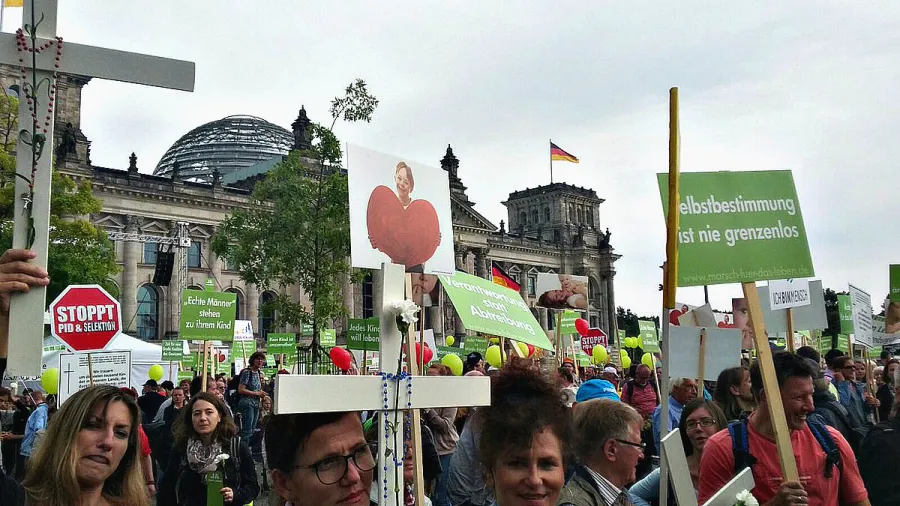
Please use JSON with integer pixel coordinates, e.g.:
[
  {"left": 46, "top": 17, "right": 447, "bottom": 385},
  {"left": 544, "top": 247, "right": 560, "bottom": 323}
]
[{"left": 669, "top": 326, "right": 742, "bottom": 381}]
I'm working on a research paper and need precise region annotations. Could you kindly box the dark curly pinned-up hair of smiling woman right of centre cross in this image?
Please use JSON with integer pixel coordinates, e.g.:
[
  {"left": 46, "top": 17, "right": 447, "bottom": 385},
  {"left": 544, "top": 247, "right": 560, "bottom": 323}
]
[{"left": 477, "top": 360, "right": 572, "bottom": 472}]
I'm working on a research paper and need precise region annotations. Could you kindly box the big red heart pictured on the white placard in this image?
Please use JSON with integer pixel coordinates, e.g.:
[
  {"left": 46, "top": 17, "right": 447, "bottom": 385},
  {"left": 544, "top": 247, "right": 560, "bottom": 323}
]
[{"left": 366, "top": 186, "right": 441, "bottom": 267}]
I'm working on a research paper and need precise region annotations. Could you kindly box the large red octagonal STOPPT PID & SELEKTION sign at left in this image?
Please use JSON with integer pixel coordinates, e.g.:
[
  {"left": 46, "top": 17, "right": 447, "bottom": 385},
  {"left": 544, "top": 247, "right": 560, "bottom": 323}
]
[{"left": 50, "top": 285, "right": 122, "bottom": 352}]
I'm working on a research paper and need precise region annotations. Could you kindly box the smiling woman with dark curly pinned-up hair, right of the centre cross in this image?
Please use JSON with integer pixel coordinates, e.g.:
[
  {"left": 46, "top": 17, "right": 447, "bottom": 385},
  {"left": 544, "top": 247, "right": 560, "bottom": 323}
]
[{"left": 477, "top": 360, "right": 572, "bottom": 506}]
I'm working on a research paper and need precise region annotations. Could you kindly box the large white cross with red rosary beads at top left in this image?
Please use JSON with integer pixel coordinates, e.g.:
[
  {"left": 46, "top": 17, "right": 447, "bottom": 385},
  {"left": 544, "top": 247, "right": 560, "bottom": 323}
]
[{"left": 0, "top": 0, "right": 194, "bottom": 375}]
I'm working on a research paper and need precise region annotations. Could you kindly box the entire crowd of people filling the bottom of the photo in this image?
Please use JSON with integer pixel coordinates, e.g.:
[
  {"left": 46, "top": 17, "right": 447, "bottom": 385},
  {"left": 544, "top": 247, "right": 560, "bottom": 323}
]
[{"left": 0, "top": 250, "right": 900, "bottom": 506}]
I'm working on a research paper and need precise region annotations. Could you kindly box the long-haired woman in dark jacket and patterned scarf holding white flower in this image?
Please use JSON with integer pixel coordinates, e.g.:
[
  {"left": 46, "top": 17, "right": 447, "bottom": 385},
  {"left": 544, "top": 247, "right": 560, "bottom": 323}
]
[{"left": 158, "top": 392, "right": 259, "bottom": 506}]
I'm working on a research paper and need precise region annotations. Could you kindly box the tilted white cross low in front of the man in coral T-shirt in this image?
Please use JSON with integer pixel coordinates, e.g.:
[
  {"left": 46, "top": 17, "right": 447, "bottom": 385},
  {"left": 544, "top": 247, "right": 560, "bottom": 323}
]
[{"left": 660, "top": 429, "right": 755, "bottom": 506}]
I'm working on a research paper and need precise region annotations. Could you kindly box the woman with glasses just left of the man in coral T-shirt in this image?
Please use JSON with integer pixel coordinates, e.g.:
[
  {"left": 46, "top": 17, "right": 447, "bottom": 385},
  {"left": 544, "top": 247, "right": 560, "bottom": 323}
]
[{"left": 629, "top": 399, "right": 728, "bottom": 505}]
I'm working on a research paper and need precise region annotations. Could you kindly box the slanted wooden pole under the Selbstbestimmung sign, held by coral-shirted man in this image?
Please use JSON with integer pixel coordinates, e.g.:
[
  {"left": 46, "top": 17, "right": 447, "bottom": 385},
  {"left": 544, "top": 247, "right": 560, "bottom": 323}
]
[{"left": 742, "top": 281, "right": 800, "bottom": 481}]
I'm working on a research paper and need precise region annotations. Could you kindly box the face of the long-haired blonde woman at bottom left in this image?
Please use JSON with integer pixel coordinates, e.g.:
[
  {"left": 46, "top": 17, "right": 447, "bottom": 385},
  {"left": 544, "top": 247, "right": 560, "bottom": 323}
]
[{"left": 74, "top": 401, "right": 132, "bottom": 487}]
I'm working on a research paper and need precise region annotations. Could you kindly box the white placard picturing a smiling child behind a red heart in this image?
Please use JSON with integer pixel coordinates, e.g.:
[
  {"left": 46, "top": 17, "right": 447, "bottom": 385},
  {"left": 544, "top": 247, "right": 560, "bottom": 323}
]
[{"left": 347, "top": 145, "right": 455, "bottom": 274}]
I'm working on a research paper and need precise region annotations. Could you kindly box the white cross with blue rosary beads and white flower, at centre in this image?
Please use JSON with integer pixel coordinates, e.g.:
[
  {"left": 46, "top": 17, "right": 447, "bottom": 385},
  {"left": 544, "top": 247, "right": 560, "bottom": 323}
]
[{"left": 273, "top": 264, "right": 491, "bottom": 506}]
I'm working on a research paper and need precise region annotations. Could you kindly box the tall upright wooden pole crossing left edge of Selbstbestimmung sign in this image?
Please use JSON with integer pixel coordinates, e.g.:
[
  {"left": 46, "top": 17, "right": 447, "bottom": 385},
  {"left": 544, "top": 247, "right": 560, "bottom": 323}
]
[{"left": 658, "top": 88, "right": 681, "bottom": 504}]
